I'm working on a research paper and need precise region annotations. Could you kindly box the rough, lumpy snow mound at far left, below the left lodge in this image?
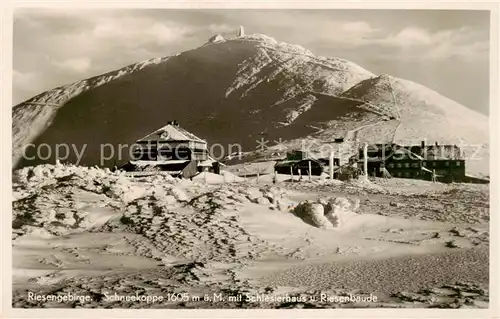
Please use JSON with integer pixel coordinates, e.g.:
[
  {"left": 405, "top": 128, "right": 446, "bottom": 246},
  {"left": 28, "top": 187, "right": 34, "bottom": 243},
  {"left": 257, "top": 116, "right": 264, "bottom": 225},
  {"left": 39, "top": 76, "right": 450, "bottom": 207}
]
[{"left": 12, "top": 164, "right": 182, "bottom": 239}]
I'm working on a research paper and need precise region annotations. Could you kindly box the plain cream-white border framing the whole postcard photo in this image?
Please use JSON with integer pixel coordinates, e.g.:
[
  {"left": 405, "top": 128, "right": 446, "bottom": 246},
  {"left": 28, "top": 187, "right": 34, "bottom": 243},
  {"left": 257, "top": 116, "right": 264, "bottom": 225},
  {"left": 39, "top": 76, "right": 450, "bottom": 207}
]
[{"left": 0, "top": 0, "right": 500, "bottom": 318}]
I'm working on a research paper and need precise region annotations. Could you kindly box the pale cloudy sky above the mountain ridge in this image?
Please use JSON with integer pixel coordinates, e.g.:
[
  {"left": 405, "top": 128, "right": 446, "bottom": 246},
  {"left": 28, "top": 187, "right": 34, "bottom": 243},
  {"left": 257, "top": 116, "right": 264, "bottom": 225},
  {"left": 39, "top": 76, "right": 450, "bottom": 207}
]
[{"left": 13, "top": 8, "right": 490, "bottom": 114}]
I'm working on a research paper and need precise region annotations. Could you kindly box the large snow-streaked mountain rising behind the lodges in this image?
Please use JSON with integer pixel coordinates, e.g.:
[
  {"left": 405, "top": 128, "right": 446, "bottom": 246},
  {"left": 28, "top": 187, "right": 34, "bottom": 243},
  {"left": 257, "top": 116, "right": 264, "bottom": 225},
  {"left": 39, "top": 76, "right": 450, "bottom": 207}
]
[{"left": 12, "top": 34, "right": 489, "bottom": 174}]
